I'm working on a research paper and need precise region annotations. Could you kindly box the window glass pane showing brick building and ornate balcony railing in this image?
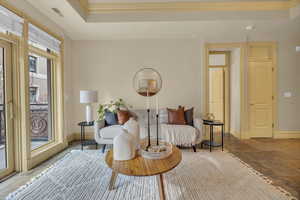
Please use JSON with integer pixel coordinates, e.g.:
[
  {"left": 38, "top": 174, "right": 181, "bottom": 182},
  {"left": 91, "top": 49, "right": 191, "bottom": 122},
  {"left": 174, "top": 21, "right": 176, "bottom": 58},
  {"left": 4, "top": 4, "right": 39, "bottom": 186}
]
[{"left": 29, "top": 53, "right": 52, "bottom": 149}]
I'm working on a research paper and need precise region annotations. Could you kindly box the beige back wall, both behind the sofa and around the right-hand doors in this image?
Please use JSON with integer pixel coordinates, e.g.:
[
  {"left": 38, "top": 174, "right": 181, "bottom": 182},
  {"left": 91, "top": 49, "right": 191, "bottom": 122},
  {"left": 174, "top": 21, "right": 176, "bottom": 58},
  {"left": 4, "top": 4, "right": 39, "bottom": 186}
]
[{"left": 72, "top": 34, "right": 300, "bottom": 135}]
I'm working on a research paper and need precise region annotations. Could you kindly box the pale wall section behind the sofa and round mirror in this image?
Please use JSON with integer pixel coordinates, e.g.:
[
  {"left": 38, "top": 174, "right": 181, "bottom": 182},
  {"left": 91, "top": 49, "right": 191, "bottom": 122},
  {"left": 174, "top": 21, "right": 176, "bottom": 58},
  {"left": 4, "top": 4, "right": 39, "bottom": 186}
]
[{"left": 72, "top": 39, "right": 203, "bottom": 132}]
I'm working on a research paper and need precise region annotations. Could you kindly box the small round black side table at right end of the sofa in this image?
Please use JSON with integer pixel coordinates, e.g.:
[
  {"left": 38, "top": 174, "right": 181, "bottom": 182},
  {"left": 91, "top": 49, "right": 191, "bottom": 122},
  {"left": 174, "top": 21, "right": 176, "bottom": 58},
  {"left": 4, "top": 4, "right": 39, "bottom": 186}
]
[{"left": 201, "top": 120, "right": 224, "bottom": 152}]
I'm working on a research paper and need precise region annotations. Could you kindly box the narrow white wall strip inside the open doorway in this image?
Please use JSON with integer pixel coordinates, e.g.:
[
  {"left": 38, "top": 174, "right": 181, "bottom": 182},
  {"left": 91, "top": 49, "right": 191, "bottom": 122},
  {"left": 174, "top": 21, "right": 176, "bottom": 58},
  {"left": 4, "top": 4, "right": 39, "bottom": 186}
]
[{"left": 230, "top": 48, "right": 241, "bottom": 136}]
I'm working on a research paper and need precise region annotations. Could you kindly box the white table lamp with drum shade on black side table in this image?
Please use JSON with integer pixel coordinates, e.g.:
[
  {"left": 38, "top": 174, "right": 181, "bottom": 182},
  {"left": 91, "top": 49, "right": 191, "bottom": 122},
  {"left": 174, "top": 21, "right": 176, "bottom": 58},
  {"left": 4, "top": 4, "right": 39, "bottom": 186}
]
[{"left": 80, "top": 90, "right": 98, "bottom": 123}]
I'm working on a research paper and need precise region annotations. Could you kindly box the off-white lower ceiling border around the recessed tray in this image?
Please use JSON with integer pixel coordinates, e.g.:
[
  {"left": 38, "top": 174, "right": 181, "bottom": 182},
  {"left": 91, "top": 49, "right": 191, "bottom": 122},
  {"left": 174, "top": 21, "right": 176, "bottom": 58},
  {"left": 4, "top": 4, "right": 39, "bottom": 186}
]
[{"left": 27, "top": 0, "right": 300, "bottom": 40}]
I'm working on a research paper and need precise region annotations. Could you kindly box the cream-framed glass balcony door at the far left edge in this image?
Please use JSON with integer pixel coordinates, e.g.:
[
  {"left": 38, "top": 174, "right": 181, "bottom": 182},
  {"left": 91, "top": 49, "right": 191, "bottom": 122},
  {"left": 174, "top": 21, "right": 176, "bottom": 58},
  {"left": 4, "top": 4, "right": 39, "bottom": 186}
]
[{"left": 0, "top": 40, "right": 15, "bottom": 178}]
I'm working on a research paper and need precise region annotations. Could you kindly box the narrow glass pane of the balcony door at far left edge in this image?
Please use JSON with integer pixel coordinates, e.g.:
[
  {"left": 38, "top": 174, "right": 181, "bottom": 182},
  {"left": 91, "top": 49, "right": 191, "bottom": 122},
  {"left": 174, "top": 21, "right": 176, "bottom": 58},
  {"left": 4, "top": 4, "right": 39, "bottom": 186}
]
[{"left": 0, "top": 47, "right": 7, "bottom": 170}]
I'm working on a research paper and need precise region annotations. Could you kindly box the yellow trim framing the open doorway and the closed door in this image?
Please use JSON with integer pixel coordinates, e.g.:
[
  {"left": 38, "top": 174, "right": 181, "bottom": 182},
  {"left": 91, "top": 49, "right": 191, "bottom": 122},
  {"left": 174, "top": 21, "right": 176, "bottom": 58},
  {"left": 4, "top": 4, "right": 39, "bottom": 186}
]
[{"left": 201, "top": 42, "right": 278, "bottom": 139}]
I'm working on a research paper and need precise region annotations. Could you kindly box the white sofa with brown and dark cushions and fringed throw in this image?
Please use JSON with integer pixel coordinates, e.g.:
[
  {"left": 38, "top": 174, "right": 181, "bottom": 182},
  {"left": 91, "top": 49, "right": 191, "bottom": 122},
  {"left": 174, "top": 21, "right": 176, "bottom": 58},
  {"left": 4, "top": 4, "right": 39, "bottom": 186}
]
[{"left": 94, "top": 109, "right": 203, "bottom": 152}]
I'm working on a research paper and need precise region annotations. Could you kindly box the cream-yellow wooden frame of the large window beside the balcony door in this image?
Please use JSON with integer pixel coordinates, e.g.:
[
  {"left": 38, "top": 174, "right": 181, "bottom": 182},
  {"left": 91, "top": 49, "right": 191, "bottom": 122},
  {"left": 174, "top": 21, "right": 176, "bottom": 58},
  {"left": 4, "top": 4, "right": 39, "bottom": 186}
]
[{"left": 0, "top": 1, "right": 68, "bottom": 171}]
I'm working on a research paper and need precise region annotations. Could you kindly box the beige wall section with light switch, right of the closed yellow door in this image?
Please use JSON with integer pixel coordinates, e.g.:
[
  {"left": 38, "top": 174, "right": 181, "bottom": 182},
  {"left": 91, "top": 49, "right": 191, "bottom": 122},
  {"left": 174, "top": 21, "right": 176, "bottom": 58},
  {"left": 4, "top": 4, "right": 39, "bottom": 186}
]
[{"left": 278, "top": 40, "right": 300, "bottom": 131}]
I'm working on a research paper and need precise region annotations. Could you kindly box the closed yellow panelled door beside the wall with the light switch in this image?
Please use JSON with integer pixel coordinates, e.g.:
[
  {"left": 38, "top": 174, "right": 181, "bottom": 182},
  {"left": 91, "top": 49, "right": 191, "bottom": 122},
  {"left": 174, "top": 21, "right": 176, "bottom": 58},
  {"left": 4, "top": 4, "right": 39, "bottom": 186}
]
[{"left": 248, "top": 44, "right": 274, "bottom": 137}]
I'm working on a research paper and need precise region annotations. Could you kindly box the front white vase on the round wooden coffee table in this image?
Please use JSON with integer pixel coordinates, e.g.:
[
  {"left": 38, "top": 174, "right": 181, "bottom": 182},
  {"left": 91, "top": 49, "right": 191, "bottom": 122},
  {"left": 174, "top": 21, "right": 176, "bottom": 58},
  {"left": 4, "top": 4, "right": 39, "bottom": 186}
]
[{"left": 113, "top": 129, "right": 136, "bottom": 160}]
